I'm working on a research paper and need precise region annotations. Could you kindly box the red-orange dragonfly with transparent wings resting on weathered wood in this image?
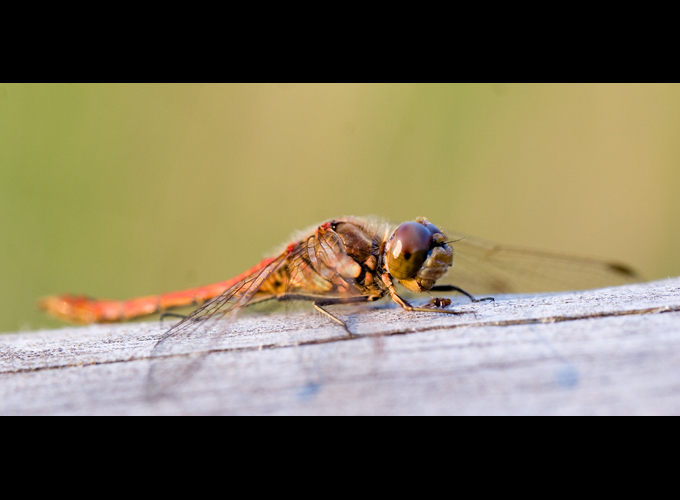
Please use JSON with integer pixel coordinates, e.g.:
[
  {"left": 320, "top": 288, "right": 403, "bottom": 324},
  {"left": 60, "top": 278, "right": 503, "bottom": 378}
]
[{"left": 39, "top": 216, "right": 639, "bottom": 341}]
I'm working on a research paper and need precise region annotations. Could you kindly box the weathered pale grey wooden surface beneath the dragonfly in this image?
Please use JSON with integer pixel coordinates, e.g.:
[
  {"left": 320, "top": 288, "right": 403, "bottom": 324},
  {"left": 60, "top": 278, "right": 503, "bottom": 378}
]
[{"left": 0, "top": 278, "right": 680, "bottom": 415}]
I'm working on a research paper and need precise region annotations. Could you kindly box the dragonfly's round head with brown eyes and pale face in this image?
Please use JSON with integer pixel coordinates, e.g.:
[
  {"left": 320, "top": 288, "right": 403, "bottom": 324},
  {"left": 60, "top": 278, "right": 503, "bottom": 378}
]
[{"left": 385, "top": 217, "right": 453, "bottom": 292}]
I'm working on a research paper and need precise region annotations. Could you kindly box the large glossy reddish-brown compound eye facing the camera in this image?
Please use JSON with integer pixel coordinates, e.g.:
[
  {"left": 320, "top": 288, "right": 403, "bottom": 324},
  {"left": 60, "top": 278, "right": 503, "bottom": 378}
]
[{"left": 387, "top": 222, "right": 432, "bottom": 280}]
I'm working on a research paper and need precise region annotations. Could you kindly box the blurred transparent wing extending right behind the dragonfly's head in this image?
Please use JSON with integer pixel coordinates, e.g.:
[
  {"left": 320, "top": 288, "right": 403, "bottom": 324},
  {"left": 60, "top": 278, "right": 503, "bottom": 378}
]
[{"left": 437, "top": 232, "right": 640, "bottom": 294}]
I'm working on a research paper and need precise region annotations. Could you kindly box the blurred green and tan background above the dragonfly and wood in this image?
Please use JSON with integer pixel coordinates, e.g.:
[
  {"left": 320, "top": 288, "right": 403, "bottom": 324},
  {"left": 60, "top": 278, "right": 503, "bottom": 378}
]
[{"left": 0, "top": 84, "right": 680, "bottom": 332}]
